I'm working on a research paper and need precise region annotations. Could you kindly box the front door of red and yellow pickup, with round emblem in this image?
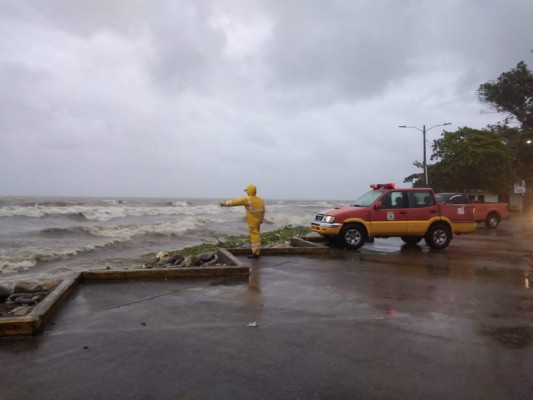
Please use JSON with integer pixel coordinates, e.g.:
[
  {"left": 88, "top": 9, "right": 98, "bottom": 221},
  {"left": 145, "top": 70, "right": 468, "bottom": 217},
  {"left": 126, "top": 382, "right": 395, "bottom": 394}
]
[{"left": 370, "top": 190, "right": 409, "bottom": 236}]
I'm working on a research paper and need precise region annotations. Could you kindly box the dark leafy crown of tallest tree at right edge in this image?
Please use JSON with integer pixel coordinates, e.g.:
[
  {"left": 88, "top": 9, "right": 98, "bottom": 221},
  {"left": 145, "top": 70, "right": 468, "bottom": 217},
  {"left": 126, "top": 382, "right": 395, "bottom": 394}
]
[{"left": 478, "top": 61, "right": 533, "bottom": 131}]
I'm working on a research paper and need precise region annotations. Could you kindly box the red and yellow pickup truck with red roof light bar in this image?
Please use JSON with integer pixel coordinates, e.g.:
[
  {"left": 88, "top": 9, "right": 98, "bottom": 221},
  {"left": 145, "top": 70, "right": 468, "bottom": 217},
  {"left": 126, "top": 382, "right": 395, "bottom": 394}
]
[{"left": 311, "top": 183, "right": 476, "bottom": 249}]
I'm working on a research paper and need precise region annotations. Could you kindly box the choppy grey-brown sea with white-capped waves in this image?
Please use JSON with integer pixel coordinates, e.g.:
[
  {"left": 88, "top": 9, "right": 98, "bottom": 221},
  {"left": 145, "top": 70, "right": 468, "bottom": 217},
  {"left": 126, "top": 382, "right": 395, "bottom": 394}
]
[{"left": 0, "top": 197, "right": 338, "bottom": 284}]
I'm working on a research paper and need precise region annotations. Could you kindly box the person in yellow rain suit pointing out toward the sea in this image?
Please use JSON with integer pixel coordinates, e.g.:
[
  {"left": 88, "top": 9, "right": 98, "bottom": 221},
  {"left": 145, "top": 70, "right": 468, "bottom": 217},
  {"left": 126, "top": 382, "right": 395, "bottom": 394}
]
[{"left": 220, "top": 185, "right": 265, "bottom": 258}]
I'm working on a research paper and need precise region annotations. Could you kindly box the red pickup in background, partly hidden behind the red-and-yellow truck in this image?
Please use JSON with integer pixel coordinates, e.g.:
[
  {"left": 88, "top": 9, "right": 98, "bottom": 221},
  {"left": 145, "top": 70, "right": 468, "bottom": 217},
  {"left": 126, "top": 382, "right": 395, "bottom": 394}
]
[{"left": 435, "top": 193, "right": 510, "bottom": 229}]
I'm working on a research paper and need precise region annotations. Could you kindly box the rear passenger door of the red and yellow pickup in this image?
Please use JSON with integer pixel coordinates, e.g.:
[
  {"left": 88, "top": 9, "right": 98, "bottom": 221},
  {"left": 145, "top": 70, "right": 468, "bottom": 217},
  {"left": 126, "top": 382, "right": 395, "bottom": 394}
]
[{"left": 408, "top": 190, "right": 439, "bottom": 236}]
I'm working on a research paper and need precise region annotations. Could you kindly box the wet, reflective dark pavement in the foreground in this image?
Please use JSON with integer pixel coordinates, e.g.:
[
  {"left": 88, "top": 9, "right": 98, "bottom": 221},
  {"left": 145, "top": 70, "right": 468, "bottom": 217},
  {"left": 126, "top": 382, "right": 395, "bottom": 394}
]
[{"left": 0, "top": 218, "right": 533, "bottom": 400}]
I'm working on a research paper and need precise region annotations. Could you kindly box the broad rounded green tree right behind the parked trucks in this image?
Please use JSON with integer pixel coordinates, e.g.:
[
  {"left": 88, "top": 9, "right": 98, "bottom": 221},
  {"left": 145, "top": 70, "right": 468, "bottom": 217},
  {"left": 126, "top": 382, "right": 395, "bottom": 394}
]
[{"left": 428, "top": 127, "right": 516, "bottom": 195}]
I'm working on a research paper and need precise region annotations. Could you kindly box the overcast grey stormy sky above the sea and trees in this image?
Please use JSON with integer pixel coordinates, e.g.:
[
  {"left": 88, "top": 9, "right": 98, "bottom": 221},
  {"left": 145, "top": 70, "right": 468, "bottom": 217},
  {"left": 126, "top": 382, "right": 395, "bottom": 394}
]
[{"left": 0, "top": 0, "right": 533, "bottom": 200}]
